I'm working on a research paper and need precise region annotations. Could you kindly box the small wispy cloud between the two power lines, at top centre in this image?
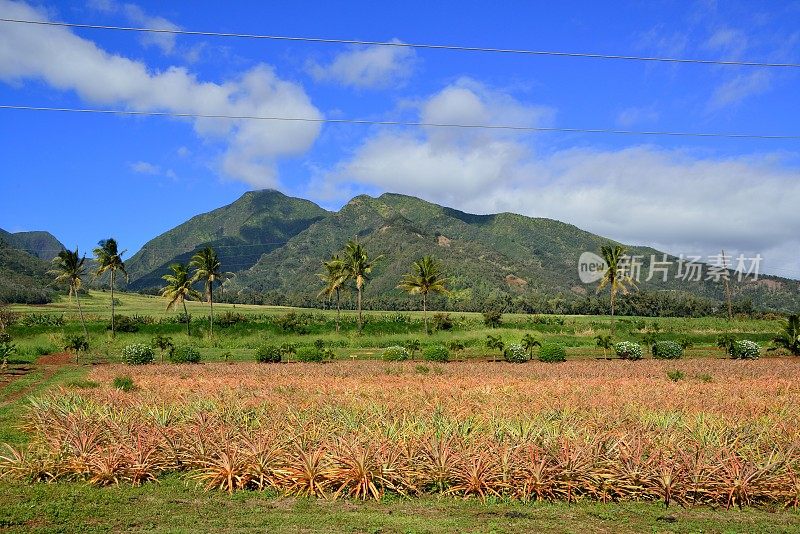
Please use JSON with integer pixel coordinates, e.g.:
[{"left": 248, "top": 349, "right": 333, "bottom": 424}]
[{"left": 307, "top": 39, "right": 416, "bottom": 89}]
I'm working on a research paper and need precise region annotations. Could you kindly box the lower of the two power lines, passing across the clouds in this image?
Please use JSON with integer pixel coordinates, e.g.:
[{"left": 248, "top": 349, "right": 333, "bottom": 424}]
[{"left": 0, "top": 104, "right": 800, "bottom": 140}]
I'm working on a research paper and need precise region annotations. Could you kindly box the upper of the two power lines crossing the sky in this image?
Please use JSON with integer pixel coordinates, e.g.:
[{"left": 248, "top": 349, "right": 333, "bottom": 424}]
[{"left": 0, "top": 18, "right": 800, "bottom": 68}]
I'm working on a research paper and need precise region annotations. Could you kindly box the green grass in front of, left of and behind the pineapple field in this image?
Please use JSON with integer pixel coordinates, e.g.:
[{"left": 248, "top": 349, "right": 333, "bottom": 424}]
[{"left": 0, "top": 292, "right": 800, "bottom": 533}]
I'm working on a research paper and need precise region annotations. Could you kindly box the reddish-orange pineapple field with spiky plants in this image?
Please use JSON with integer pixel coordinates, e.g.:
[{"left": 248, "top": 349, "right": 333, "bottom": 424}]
[{"left": 6, "top": 358, "right": 800, "bottom": 508}]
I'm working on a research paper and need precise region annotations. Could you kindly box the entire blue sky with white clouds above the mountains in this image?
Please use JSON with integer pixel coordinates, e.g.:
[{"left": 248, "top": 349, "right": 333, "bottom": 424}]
[{"left": 0, "top": 0, "right": 800, "bottom": 277}]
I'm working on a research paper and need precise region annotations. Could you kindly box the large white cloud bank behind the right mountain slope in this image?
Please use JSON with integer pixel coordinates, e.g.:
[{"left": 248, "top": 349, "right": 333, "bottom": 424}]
[{"left": 324, "top": 82, "right": 800, "bottom": 280}]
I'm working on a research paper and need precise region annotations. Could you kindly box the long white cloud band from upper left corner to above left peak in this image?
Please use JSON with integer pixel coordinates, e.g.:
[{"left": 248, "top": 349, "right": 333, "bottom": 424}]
[{"left": 0, "top": 0, "right": 322, "bottom": 187}]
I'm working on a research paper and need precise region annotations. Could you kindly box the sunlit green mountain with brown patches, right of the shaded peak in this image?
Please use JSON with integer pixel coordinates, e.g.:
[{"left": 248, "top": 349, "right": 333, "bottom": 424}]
[{"left": 226, "top": 194, "right": 800, "bottom": 314}]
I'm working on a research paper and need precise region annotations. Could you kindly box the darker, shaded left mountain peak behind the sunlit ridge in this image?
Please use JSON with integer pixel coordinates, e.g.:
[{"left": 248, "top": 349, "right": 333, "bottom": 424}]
[{"left": 125, "top": 190, "right": 329, "bottom": 291}]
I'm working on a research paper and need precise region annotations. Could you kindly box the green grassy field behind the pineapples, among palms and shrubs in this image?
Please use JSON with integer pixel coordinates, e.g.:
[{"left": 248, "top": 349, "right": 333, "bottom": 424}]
[{"left": 0, "top": 292, "right": 781, "bottom": 362}]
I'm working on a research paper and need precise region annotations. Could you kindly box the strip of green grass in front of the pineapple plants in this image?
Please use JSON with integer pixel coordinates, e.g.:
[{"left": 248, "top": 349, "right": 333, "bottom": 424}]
[{"left": 0, "top": 477, "right": 800, "bottom": 533}]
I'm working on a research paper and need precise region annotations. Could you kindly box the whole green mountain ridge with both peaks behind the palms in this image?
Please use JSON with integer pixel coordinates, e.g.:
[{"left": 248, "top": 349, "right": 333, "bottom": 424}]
[{"left": 119, "top": 190, "right": 800, "bottom": 314}]
